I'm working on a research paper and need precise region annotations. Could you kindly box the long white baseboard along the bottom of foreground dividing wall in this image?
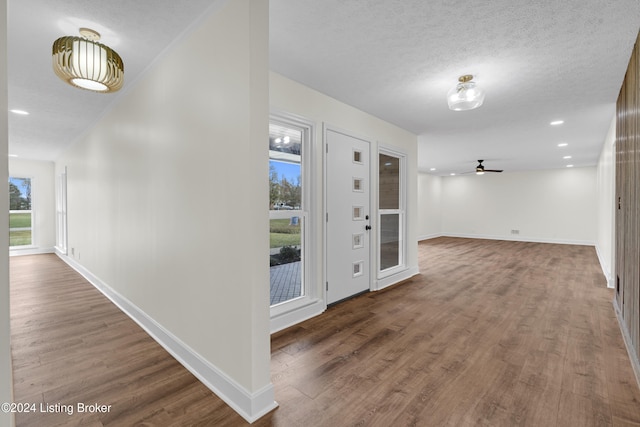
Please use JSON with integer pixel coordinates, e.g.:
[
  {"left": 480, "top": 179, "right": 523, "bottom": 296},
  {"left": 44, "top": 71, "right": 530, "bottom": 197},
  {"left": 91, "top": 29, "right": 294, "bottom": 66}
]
[{"left": 57, "top": 254, "right": 278, "bottom": 423}]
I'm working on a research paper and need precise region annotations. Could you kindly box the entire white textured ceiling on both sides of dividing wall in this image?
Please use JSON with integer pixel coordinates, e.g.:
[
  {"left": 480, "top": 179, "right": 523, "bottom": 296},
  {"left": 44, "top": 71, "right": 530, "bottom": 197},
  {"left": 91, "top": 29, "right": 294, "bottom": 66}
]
[{"left": 9, "top": 0, "right": 640, "bottom": 175}]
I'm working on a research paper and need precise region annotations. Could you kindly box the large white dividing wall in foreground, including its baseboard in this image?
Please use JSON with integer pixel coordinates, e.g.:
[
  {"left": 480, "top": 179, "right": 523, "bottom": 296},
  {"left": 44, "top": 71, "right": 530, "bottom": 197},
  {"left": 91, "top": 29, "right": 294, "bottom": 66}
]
[{"left": 56, "top": 0, "right": 275, "bottom": 419}]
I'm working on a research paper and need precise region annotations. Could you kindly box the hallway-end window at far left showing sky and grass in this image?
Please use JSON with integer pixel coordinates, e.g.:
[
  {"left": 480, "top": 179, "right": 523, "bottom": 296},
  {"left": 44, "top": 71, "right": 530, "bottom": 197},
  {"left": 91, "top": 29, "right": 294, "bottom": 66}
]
[{"left": 9, "top": 177, "right": 33, "bottom": 246}]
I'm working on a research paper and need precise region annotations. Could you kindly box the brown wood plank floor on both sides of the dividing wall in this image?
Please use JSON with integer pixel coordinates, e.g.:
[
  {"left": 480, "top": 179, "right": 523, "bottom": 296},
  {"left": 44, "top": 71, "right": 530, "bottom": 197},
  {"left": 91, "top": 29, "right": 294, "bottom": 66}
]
[{"left": 11, "top": 238, "right": 640, "bottom": 427}]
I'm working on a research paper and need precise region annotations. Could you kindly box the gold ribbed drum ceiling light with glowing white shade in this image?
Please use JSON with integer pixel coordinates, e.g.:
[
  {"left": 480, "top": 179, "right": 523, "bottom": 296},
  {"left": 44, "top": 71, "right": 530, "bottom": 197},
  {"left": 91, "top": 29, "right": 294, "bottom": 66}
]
[{"left": 53, "top": 28, "right": 124, "bottom": 93}]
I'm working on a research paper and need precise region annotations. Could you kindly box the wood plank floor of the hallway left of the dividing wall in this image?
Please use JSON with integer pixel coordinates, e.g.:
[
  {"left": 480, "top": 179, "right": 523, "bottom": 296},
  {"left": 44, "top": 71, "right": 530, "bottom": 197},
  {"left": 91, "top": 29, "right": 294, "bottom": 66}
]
[{"left": 10, "top": 255, "right": 247, "bottom": 427}]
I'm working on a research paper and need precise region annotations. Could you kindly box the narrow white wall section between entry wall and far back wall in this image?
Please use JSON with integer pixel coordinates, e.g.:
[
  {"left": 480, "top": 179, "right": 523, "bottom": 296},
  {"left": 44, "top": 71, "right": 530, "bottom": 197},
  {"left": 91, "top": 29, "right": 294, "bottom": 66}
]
[{"left": 418, "top": 172, "right": 442, "bottom": 240}]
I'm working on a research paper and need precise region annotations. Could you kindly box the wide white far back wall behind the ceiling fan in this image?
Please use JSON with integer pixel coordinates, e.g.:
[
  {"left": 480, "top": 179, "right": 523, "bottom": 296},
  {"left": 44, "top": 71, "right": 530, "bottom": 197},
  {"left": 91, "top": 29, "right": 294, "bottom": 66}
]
[{"left": 442, "top": 167, "right": 598, "bottom": 245}]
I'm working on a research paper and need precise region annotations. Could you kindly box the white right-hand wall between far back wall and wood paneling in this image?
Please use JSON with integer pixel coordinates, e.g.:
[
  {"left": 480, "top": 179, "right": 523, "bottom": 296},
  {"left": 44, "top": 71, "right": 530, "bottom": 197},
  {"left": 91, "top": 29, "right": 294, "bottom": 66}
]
[{"left": 596, "top": 117, "right": 616, "bottom": 288}]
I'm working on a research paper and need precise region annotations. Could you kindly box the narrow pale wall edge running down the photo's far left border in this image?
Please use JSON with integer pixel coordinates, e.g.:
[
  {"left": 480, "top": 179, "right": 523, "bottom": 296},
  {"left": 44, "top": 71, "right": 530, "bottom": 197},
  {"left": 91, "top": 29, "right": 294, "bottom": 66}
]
[{"left": 0, "top": 0, "right": 15, "bottom": 426}]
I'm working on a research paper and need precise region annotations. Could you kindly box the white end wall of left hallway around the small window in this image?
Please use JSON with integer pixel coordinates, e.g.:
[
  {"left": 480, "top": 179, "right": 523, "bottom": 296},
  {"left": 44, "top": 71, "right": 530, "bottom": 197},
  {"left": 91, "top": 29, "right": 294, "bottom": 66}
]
[{"left": 9, "top": 158, "right": 56, "bottom": 255}]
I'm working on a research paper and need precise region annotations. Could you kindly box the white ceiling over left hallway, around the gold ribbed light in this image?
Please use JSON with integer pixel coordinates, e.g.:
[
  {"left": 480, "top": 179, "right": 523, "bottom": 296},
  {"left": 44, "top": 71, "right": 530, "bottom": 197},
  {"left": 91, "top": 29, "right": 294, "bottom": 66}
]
[{"left": 7, "top": 0, "right": 215, "bottom": 160}]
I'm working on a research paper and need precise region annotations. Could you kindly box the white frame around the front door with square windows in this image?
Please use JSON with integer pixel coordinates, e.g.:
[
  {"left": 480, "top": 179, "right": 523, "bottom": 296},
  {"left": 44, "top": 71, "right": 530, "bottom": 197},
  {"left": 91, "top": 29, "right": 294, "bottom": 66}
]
[{"left": 322, "top": 122, "right": 378, "bottom": 307}]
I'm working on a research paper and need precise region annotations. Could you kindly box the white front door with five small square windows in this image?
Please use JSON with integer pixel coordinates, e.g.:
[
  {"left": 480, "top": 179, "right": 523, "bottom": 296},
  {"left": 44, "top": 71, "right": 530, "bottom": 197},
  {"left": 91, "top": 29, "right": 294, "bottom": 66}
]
[{"left": 325, "top": 129, "right": 371, "bottom": 304}]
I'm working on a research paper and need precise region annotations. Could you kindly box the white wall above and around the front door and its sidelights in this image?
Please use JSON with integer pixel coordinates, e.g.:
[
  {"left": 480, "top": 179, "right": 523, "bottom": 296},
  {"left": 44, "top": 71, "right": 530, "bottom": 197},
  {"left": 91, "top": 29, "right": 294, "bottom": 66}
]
[{"left": 269, "top": 72, "right": 418, "bottom": 295}]
